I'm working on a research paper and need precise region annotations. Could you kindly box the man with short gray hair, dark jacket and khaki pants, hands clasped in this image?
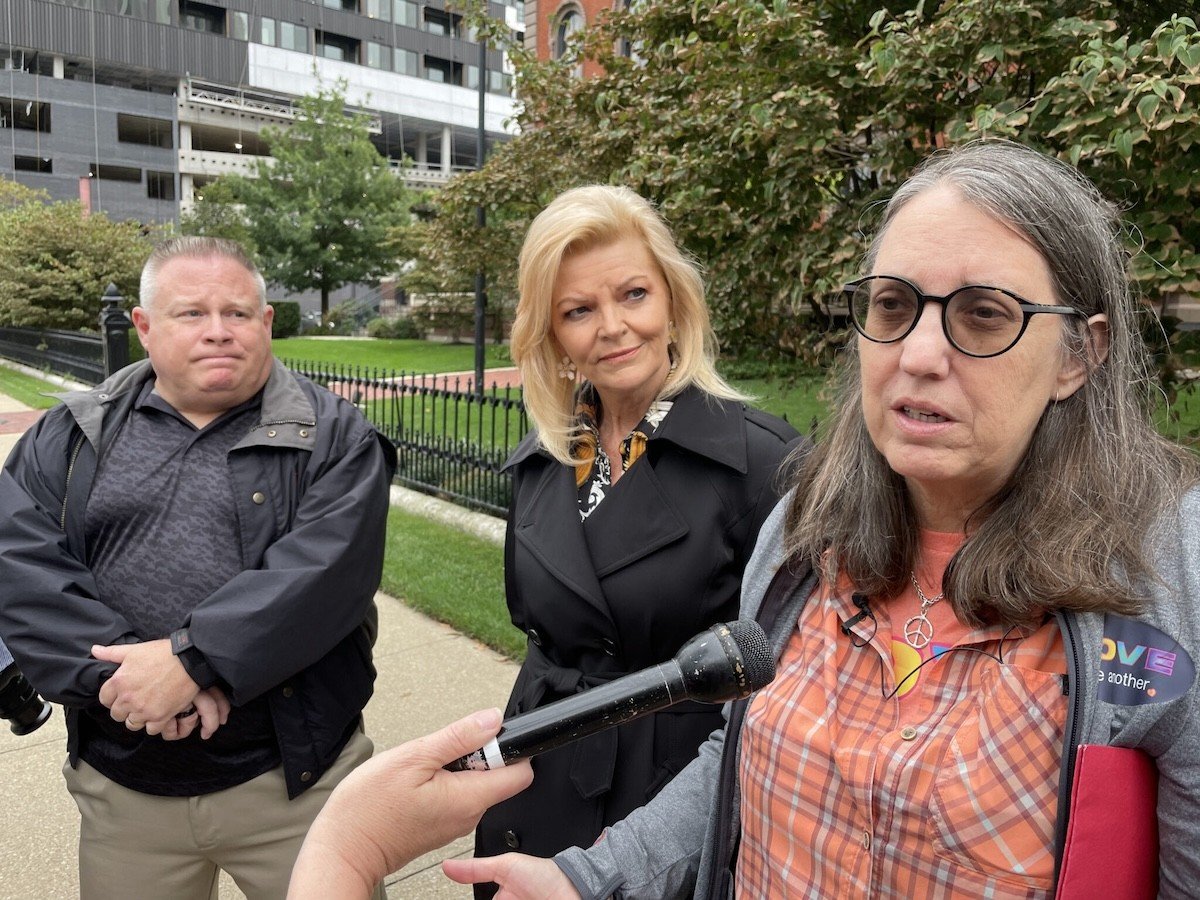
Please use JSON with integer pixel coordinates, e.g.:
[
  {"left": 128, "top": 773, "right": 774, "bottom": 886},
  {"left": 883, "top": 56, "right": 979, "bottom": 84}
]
[{"left": 0, "top": 238, "right": 396, "bottom": 900}]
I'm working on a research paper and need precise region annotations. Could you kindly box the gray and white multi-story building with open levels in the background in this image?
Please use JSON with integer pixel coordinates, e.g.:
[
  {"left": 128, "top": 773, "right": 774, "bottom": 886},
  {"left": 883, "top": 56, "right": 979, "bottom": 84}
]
[{"left": 0, "top": 0, "right": 524, "bottom": 222}]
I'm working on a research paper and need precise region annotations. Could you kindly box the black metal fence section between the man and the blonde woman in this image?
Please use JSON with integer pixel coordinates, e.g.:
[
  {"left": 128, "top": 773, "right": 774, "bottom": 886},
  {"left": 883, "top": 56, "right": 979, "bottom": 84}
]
[{"left": 283, "top": 359, "right": 529, "bottom": 516}]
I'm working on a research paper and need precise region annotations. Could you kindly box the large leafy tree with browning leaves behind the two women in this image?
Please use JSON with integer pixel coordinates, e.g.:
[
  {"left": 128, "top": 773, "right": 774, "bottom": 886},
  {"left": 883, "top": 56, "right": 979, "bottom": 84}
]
[{"left": 410, "top": 0, "right": 1200, "bottom": 369}]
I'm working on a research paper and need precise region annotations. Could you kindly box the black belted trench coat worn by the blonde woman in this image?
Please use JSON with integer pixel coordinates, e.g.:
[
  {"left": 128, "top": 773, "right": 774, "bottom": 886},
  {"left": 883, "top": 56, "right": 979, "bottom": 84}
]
[{"left": 475, "top": 388, "right": 799, "bottom": 895}]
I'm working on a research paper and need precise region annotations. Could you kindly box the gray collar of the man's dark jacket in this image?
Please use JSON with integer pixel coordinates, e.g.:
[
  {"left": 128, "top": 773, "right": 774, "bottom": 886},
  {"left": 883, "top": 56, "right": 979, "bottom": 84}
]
[{"left": 52, "top": 359, "right": 317, "bottom": 450}]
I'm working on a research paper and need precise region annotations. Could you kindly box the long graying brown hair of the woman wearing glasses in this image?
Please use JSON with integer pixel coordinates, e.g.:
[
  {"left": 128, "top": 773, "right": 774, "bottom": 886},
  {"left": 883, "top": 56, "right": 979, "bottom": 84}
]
[{"left": 787, "top": 140, "right": 1200, "bottom": 625}]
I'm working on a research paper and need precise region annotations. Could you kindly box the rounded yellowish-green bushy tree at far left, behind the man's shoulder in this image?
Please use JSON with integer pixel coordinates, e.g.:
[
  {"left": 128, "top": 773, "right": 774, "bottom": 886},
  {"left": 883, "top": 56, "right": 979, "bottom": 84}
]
[{"left": 0, "top": 179, "right": 154, "bottom": 330}]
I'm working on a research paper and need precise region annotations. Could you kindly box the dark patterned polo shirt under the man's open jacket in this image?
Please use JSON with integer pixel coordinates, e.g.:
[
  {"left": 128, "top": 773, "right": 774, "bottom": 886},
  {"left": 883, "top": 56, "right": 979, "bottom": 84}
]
[{"left": 79, "top": 382, "right": 281, "bottom": 797}]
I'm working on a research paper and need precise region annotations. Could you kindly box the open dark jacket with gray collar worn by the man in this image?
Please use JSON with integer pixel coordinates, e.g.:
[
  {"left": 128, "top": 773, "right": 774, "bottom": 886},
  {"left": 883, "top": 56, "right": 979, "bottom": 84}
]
[{"left": 0, "top": 361, "right": 396, "bottom": 797}]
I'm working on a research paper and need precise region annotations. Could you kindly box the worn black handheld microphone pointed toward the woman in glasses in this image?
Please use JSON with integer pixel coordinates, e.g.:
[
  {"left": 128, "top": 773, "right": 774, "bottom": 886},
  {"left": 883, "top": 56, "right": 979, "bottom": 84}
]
[{"left": 445, "top": 620, "right": 775, "bottom": 772}]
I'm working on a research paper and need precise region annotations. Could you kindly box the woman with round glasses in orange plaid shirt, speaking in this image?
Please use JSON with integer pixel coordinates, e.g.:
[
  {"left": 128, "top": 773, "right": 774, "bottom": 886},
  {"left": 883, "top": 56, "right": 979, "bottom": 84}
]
[{"left": 445, "top": 142, "right": 1200, "bottom": 899}]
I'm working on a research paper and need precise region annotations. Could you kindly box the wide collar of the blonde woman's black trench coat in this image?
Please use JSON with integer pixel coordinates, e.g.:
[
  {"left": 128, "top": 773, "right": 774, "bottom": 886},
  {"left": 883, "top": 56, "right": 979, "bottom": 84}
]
[{"left": 502, "top": 384, "right": 750, "bottom": 475}]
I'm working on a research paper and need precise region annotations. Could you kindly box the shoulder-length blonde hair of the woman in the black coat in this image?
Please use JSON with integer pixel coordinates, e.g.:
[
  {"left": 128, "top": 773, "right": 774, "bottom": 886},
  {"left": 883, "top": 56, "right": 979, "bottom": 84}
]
[{"left": 512, "top": 185, "right": 745, "bottom": 464}]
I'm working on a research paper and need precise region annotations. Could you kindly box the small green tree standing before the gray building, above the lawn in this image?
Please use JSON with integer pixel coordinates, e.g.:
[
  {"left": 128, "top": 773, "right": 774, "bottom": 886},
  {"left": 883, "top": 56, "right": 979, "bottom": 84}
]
[{"left": 184, "top": 85, "right": 408, "bottom": 316}]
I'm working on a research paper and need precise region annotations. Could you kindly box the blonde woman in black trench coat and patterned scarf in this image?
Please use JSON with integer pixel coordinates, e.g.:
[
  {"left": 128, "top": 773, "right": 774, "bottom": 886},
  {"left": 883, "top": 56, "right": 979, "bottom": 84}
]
[{"left": 476, "top": 186, "right": 798, "bottom": 894}]
